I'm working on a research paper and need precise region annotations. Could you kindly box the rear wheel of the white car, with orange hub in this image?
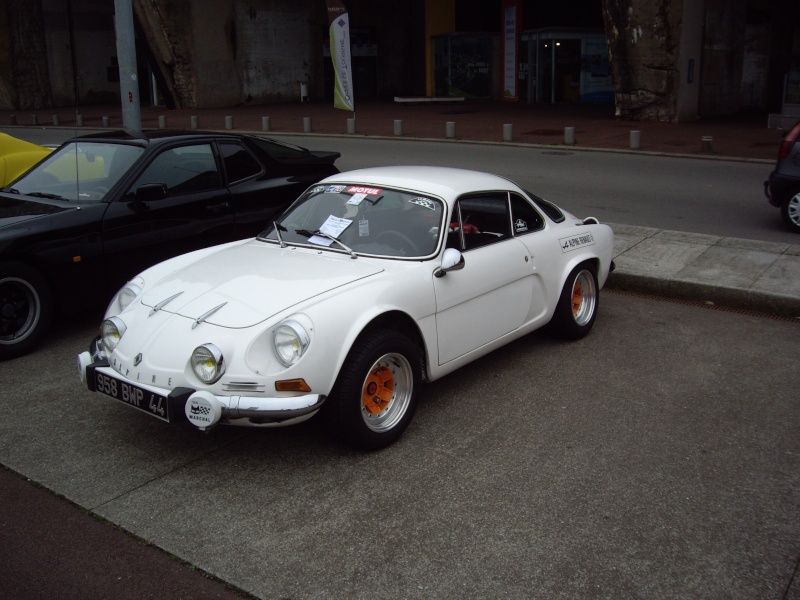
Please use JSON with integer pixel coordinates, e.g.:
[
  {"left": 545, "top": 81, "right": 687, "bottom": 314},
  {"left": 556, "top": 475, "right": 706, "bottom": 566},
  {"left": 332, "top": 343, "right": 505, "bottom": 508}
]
[{"left": 548, "top": 262, "right": 600, "bottom": 340}]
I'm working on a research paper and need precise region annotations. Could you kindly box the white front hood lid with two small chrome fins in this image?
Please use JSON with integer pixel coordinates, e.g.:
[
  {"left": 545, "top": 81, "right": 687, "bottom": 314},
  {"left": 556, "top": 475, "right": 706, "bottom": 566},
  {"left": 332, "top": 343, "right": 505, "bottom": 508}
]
[{"left": 141, "top": 240, "right": 383, "bottom": 328}]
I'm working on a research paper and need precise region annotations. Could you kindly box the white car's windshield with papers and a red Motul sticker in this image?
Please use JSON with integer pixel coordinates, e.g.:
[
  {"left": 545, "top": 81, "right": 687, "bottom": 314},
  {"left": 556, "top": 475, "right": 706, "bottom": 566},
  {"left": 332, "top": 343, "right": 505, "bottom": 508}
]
[{"left": 259, "top": 184, "right": 444, "bottom": 258}]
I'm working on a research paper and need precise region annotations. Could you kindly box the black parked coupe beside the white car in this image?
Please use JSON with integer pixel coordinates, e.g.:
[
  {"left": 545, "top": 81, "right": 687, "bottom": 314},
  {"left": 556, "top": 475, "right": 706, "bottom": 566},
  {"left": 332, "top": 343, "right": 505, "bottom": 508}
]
[{"left": 0, "top": 131, "right": 339, "bottom": 359}]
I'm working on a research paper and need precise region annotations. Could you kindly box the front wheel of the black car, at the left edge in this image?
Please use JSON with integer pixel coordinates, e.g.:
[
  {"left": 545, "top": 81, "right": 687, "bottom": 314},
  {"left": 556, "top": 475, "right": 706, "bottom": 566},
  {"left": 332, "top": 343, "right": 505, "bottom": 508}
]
[{"left": 0, "top": 262, "right": 53, "bottom": 360}]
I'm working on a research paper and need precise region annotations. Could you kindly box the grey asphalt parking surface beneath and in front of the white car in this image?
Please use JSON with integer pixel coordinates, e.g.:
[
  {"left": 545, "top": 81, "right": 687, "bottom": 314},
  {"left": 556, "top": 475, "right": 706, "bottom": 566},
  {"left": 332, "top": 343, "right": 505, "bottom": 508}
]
[{"left": 0, "top": 291, "right": 800, "bottom": 600}]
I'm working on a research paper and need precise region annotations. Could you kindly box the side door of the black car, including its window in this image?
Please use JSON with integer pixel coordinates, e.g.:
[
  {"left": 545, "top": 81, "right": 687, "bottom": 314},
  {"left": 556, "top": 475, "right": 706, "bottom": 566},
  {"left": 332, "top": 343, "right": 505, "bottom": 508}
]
[{"left": 98, "top": 141, "right": 235, "bottom": 288}]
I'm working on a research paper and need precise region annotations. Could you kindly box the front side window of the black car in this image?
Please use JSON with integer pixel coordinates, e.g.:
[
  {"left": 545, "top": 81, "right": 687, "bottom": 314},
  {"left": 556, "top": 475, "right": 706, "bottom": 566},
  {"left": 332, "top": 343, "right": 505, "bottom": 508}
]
[{"left": 131, "top": 144, "right": 222, "bottom": 196}]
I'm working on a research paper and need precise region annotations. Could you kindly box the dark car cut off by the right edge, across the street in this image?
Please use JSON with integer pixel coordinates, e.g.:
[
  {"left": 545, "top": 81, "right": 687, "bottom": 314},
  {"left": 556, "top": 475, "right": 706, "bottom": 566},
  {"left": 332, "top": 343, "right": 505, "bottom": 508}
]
[{"left": 764, "top": 121, "right": 800, "bottom": 233}]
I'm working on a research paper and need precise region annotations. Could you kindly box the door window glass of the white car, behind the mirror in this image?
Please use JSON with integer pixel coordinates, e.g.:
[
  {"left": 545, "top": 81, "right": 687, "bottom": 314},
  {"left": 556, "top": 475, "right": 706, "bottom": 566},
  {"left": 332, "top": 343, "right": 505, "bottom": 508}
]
[{"left": 447, "top": 192, "right": 511, "bottom": 250}]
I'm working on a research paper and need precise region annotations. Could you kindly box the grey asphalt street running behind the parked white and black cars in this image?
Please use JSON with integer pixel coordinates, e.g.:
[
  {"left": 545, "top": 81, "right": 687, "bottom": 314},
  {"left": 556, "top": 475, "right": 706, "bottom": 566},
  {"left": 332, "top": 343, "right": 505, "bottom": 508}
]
[{"left": 0, "top": 128, "right": 798, "bottom": 244}]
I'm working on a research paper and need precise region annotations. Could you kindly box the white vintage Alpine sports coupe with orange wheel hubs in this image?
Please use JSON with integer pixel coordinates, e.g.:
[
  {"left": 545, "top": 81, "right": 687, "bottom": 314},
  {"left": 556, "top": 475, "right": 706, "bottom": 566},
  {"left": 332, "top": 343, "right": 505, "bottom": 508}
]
[{"left": 79, "top": 167, "right": 613, "bottom": 449}]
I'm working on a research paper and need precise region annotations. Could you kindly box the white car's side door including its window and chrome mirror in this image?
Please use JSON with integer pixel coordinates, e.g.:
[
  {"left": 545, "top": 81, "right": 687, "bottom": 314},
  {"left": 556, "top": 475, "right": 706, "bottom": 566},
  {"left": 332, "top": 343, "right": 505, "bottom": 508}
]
[{"left": 433, "top": 192, "right": 533, "bottom": 365}]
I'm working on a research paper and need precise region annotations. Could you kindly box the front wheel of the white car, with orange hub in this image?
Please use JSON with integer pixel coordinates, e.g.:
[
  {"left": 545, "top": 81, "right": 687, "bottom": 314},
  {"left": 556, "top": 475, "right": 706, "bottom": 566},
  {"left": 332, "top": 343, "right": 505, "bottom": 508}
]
[{"left": 323, "top": 330, "right": 422, "bottom": 450}]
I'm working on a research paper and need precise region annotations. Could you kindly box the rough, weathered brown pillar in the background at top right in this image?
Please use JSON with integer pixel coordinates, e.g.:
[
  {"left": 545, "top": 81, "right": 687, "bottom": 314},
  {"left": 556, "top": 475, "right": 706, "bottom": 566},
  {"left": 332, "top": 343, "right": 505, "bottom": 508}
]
[{"left": 602, "top": 0, "right": 683, "bottom": 122}]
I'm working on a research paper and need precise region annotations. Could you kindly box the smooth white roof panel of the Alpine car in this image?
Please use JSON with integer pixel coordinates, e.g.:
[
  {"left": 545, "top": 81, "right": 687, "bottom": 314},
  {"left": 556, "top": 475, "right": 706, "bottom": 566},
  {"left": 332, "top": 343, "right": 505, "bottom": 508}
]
[{"left": 324, "top": 166, "right": 522, "bottom": 200}]
